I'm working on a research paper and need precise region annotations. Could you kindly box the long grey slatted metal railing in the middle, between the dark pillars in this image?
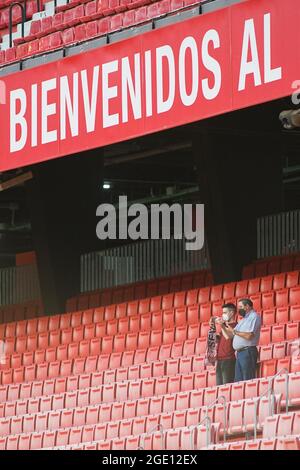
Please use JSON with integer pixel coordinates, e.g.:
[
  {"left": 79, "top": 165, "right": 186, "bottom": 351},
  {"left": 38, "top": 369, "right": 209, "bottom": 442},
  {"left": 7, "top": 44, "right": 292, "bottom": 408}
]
[{"left": 80, "top": 239, "right": 210, "bottom": 293}]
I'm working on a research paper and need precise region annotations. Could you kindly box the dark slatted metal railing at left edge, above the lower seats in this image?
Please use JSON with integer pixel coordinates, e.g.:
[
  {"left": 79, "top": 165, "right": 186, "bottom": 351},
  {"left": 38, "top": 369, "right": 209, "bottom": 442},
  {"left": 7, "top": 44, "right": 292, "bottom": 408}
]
[{"left": 0, "top": 265, "right": 41, "bottom": 306}]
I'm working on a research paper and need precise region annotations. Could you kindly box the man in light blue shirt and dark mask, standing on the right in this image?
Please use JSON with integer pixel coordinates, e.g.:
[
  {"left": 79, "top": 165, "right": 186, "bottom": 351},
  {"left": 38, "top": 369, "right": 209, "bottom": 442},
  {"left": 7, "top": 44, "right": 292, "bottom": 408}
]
[{"left": 225, "top": 299, "right": 261, "bottom": 382}]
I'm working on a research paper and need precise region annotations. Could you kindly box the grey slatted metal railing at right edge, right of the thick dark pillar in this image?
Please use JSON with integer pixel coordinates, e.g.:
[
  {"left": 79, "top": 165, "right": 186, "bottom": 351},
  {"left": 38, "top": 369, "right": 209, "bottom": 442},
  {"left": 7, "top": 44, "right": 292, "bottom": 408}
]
[{"left": 257, "top": 210, "right": 300, "bottom": 259}]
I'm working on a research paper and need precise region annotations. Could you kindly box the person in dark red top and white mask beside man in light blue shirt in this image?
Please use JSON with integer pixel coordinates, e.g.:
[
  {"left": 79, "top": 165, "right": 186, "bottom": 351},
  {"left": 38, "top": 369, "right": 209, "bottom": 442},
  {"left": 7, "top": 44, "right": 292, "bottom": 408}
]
[{"left": 210, "top": 303, "right": 236, "bottom": 385}]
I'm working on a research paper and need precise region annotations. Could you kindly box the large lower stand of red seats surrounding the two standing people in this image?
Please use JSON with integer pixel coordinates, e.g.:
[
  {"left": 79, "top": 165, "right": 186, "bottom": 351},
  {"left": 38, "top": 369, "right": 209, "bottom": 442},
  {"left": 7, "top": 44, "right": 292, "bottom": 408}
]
[{"left": 0, "top": 262, "right": 300, "bottom": 450}]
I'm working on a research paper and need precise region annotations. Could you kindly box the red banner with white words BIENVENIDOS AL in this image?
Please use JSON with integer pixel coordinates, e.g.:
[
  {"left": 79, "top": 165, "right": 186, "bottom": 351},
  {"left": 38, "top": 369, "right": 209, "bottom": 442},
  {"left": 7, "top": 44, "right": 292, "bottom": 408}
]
[{"left": 0, "top": 0, "right": 300, "bottom": 171}]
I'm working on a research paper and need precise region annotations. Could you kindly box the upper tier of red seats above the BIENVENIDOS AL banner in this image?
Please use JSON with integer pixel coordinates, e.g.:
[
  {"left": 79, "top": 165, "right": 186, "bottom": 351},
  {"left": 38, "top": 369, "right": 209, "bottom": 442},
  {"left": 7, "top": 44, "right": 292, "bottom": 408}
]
[{"left": 0, "top": 0, "right": 211, "bottom": 65}]
